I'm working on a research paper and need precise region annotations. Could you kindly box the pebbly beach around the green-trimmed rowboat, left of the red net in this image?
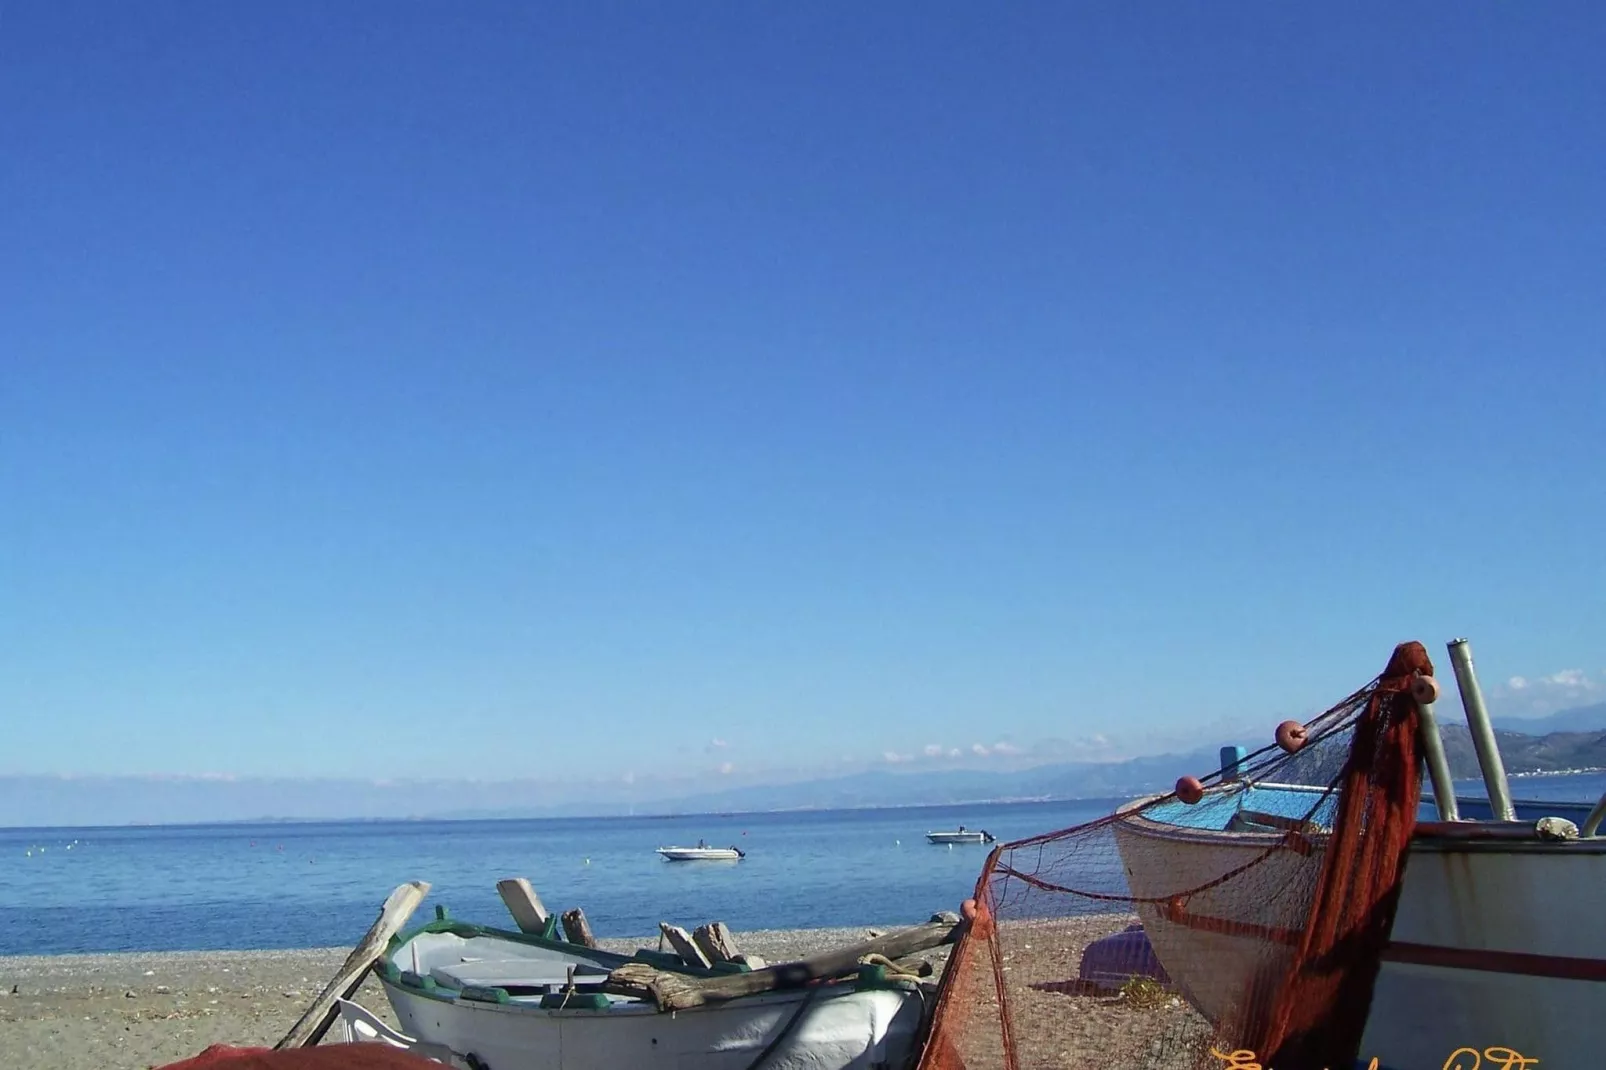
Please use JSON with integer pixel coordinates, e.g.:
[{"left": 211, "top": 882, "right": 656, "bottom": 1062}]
[{"left": 0, "top": 925, "right": 948, "bottom": 1070}]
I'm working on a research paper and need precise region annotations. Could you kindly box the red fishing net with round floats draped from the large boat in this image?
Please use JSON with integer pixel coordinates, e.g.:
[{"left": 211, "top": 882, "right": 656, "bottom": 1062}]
[{"left": 920, "top": 643, "right": 1433, "bottom": 1070}]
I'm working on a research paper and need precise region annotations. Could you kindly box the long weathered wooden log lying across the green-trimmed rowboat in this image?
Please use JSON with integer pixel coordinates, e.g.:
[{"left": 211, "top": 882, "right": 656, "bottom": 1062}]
[{"left": 602, "top": 922, "right": 960, "bottom": 1011}]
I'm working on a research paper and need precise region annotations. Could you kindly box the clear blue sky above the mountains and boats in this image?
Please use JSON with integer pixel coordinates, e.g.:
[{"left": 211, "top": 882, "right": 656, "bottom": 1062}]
[{"left": 0, "top": 2, "right": 1606, "bottom": 790}]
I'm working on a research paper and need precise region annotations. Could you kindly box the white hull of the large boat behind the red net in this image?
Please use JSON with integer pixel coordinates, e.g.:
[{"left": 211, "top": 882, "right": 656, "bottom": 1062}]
[{"left": 1113, "top": 800, "right": 1606, "bottom": 1070}]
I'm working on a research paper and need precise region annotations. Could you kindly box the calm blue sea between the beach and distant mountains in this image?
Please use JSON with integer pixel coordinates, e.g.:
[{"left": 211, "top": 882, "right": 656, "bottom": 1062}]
[{"left": 0, "top": 773, "right": 1606, "bottom": 956}]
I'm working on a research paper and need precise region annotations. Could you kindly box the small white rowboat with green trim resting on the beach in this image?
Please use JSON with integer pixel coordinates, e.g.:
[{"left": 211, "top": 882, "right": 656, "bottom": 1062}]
[{"left": 368, "top": 921, "right": 928, "bottom": 1070}]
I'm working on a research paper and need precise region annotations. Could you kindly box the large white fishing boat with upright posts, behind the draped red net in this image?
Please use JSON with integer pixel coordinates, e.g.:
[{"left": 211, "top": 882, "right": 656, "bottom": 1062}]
[{"left": 1111, "top": 639, "right": 1606, "bottom": 1070}]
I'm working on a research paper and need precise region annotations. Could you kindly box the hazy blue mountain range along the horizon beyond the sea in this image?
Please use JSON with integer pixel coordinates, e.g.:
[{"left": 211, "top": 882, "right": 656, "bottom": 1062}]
[{"left": 0, "top": 704, "right": 1606, "bottom": 827}]
